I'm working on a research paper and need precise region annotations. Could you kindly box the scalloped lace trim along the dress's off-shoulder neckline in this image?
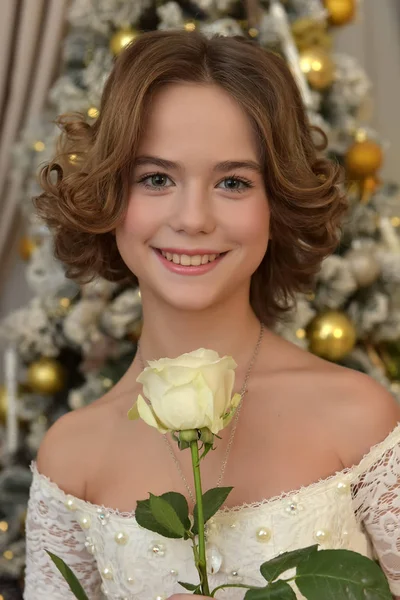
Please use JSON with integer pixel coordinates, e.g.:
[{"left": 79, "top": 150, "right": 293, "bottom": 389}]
[{"left": 30, "top": 422, "right": 400, "bottom": 519}]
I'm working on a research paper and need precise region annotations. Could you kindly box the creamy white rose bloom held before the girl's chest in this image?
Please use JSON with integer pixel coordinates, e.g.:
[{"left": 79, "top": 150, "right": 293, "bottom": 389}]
[{"left": 128, "top": 348, "right": 240, "bottom": 434}]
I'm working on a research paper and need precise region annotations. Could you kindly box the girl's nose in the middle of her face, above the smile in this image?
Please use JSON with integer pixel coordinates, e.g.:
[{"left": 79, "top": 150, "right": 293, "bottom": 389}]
[{"left": 170, "top": 182, "right": 215, "bottom": 235}]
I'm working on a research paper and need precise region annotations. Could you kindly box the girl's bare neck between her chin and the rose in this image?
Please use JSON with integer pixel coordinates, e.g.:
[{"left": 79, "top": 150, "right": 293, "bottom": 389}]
[{"left": 140, "top": 290, "right": 260, "bottom": 367}]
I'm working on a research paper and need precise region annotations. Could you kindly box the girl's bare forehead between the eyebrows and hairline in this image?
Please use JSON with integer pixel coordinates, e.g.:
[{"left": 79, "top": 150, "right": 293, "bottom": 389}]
[{"left": 139, "top": 83, "right": 257, "bottom": 160}]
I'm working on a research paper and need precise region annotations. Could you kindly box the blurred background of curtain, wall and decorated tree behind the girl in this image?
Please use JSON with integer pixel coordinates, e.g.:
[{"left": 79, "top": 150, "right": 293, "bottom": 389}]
[{"left": 0, "top": 0, "right": 400, "bottom": 600}]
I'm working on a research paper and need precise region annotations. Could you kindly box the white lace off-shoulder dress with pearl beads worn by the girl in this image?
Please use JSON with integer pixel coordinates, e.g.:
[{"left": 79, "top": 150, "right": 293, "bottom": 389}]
[{"left": 24, "top": 423, "right": 400, "bottom": 600}]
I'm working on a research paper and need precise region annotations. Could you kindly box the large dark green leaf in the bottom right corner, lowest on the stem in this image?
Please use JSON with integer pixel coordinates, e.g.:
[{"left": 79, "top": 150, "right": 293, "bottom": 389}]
[{"left": 296, "top": 550, "right": 392, "bottom": 600}]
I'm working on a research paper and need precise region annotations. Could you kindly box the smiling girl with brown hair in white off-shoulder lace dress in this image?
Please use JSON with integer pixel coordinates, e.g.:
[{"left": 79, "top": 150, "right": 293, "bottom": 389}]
[{"left": 25, "top": 32, "right": 400, "bottom": 600}]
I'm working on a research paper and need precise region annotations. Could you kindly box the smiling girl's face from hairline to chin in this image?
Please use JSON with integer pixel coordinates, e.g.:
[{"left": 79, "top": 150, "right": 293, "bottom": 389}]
[{"left": 116, "top": 84, "right": 270, "bottom": 310}]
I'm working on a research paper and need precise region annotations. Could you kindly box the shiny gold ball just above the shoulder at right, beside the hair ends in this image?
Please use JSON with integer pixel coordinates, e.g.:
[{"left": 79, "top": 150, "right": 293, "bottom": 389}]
[{"left": 307, "top": 310, "right": 357, "bottom": 361}]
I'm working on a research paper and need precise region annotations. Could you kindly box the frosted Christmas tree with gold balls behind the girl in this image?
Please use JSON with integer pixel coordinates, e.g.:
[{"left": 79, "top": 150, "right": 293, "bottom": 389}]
[{"left": 0, "top": 0, "right": 400, "bottom": 600}]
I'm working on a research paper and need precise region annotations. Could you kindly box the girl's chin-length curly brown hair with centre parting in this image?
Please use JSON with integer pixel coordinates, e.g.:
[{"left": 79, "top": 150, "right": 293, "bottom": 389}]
[{"left": 34, "top": 31, "right": 346, "bottom": 325}]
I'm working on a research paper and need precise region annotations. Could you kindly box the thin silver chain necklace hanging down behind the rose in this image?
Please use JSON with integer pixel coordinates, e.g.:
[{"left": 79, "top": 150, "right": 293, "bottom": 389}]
[{"left": 137, "top": 323, "right": 264, "bottom": 504}]
